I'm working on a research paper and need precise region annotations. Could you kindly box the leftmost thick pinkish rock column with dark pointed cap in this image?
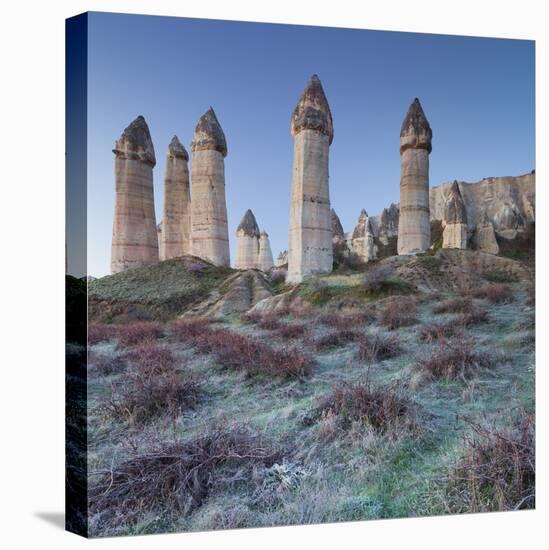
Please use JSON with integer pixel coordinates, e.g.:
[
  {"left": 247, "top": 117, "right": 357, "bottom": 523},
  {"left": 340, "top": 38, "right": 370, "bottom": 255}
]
[{"left": 111, "top": 116, "right": 158, "bottom": 273}]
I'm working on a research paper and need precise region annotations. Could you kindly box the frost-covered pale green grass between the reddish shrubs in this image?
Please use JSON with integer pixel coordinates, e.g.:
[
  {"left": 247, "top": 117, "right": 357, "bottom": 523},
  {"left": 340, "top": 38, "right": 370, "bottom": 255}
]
[{"left": 89, "top": 275, "right": 534, "bottom": 535}]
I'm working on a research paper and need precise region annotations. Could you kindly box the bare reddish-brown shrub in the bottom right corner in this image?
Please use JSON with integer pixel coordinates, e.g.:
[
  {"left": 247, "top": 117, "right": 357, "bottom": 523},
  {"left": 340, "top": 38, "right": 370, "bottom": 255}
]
[{"left": 446, "top": 412, "right": 536, "bottom": 512}]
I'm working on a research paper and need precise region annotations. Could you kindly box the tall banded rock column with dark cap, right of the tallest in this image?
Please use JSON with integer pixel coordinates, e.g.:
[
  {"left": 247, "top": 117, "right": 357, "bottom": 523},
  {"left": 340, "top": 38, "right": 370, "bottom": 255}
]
[{"left": 398, "top": 97, "right": 433, "bottom": 254}]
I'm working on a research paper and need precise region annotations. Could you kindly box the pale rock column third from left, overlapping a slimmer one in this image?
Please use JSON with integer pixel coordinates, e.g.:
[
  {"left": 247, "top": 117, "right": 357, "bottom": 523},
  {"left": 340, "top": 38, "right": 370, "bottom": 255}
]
[{"left": 191, "top": 107, "right": 230, "bottom": 267}]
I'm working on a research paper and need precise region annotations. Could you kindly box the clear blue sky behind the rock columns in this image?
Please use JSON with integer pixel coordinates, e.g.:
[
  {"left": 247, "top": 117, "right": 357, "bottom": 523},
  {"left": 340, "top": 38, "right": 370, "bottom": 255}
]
[{"left": 84, "top": 13, "right": 535, "bottom": 276}]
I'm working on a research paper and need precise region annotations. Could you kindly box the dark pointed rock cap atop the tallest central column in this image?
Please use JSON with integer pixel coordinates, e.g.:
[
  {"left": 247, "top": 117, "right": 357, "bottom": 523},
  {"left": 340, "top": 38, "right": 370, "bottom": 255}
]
[{"left": 291, "top": 74, "right": 334, "bottom": 144}]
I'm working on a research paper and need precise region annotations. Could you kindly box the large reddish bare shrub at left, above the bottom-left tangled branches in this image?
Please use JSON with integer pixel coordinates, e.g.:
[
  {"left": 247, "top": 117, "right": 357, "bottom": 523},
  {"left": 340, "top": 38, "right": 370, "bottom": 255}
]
[{"left": 103, "top": 342, "right": 198, "bottom": 424}]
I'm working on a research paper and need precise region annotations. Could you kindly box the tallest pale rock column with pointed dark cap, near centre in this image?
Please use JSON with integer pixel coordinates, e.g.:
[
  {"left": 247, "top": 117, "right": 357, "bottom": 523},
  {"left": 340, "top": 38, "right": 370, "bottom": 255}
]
[{"left": 287, "top": 75, "right": 334, "bottom": 283}]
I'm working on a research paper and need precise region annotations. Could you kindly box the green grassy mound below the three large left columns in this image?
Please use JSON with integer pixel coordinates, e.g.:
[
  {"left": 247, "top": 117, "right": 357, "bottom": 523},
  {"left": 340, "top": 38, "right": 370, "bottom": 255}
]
[{"left": 88, "top": 257, "right": 232, "bottom": 322}]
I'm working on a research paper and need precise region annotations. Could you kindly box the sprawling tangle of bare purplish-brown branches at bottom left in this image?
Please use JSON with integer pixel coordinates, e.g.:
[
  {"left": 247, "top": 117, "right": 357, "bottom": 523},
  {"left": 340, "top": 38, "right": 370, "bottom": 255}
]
[{"left": 90, "top": 426, "right": 279, "bottom": 526}]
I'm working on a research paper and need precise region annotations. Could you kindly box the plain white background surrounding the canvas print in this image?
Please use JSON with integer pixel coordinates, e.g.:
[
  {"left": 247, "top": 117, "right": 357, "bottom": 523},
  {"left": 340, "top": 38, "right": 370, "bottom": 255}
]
[{"left": 0, "top": 0, "right": 549, "bottom": 550}]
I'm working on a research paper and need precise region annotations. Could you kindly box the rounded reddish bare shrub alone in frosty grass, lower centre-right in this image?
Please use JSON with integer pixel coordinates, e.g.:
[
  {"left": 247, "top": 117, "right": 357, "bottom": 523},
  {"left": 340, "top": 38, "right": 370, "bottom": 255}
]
[{"left": 315, "top": 382, "right": 418, "bottom": 433}]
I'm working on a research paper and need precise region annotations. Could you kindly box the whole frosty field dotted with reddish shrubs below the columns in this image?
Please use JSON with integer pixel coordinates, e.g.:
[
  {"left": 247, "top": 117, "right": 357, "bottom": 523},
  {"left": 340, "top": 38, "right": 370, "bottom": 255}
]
[{"left": 85, "top": 258, "right": 535, "bottom": 535}]
